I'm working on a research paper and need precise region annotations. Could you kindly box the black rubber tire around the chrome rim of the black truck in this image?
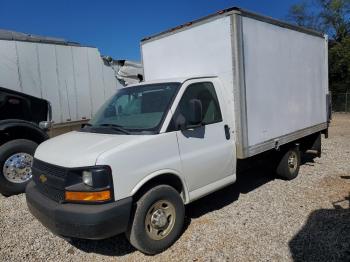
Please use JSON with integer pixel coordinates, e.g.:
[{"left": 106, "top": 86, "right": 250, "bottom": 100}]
[{"left": 0, "top": 139, "right": 38, "bottom": 196}]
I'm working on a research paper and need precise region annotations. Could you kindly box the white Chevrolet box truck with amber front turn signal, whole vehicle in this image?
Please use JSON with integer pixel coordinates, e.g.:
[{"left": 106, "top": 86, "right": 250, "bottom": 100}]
[{"left": 26, "top": 8, "right": 328, "bottom": 254}]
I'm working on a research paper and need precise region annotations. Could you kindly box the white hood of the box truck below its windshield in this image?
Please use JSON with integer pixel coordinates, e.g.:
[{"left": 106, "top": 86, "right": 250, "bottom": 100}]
[{"left": 35, "top": 131, "right": 146, "bottom": 167}]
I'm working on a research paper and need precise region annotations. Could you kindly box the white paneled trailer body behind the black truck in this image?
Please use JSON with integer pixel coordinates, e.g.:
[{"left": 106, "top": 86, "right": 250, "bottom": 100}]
[{"left": 0, "top": 30, "right": 123, "bottom": 125}]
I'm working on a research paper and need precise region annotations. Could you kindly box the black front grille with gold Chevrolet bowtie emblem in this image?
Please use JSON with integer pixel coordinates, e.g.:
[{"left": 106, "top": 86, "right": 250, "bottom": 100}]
[{"left": 32, "top": 159, "right": 68, "bottom": 202}]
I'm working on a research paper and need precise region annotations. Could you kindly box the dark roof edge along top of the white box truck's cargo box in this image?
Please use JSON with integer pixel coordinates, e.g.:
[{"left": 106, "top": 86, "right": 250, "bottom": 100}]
[{"left": 141, "top": 7, "right": 324, "bottom": 42}]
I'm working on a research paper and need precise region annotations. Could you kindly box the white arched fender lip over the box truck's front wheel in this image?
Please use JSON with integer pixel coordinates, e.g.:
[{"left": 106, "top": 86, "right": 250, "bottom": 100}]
[{"left": 130, "top": 169, "right": 190, "bottom": 204}]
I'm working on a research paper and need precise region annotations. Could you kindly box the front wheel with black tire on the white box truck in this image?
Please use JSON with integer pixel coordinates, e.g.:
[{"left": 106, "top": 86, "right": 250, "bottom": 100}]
[{"left": 126, "top": 185, "right": 185, "bottom": 255}]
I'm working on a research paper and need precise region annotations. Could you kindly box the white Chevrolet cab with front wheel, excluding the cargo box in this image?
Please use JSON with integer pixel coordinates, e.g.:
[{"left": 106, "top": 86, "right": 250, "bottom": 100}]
[{"left": 26, "top": 77, "right": 236, "bottom": 253}]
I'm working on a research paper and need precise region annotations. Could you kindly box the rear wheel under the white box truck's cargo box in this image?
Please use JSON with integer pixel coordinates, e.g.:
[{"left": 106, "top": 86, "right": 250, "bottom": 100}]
[{"left": 276, "top": 147, "right": 301, "bottom": 180}]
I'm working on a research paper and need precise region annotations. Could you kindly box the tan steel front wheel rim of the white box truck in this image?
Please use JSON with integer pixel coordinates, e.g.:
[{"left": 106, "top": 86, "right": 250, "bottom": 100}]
[{"left": 145, "top": 200, "right": 176, "bottom": 240}]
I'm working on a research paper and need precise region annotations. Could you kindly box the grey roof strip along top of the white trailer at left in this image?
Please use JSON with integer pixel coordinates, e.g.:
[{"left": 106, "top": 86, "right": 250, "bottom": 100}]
[{"left": 0, "top": 29, "right": 81, "bottom": 46}]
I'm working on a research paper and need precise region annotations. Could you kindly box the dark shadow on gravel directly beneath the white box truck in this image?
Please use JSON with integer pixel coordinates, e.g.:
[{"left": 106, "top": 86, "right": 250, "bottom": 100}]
[{"left": 70, "top": 151, "right": 314, "bottom": 257}]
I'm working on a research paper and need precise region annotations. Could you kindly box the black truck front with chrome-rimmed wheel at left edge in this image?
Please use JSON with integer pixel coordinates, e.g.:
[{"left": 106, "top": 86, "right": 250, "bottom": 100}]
[{"left": 0, "top": 87, "right": 51, "bottom": 196}]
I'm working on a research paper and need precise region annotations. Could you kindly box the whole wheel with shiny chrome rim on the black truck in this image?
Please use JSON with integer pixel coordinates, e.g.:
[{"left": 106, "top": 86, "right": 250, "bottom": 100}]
[{"left": 0, "top": 139, "right": 38, "bottom": 196}]
